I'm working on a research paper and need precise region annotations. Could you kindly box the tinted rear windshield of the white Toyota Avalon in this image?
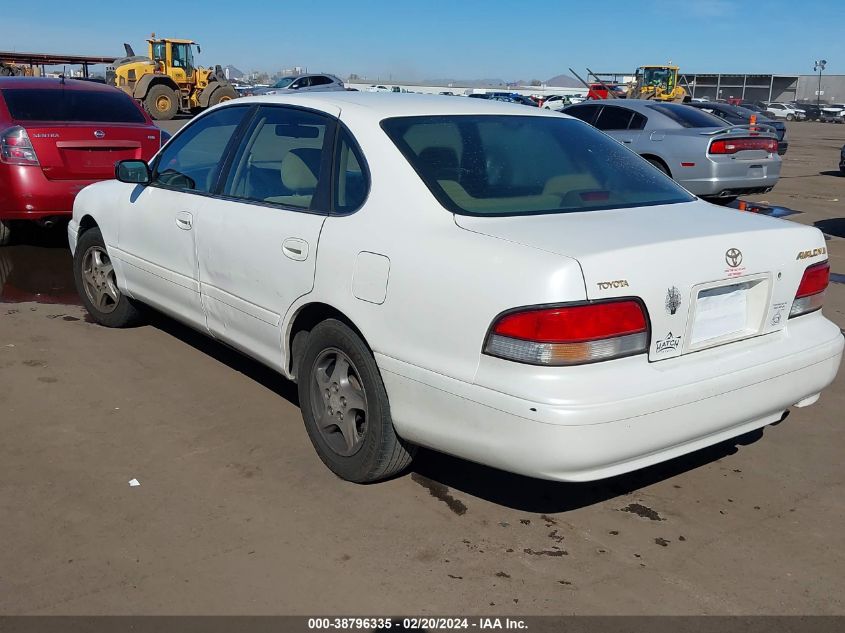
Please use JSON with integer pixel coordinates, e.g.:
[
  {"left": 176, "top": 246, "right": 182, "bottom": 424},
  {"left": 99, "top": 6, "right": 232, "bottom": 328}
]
[{"left": 381, "top": 115, "right": 694, "bottom": 216}]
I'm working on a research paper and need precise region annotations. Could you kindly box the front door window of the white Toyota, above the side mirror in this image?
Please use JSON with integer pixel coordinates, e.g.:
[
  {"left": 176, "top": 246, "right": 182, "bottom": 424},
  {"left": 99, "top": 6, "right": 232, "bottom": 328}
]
[{"left": 152, "top": 106, "right": 249, "bottom": 193}]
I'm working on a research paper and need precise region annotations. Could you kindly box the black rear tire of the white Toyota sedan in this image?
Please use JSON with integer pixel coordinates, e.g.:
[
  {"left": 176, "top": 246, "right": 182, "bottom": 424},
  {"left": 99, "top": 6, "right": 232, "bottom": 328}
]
[{"left": 297, "top": 319, "right": 416, "bottom": 483}]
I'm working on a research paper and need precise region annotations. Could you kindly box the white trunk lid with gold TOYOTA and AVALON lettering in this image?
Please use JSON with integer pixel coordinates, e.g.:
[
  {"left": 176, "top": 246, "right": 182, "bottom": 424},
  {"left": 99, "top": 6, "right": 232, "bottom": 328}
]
[{"left": 456, "top": 201, "right": 826, "bottom": 361}]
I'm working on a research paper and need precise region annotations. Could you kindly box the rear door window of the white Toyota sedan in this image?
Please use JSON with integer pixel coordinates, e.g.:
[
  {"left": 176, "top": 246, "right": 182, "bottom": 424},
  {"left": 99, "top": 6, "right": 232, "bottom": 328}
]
[{"left": 223, "top": 106, "right": 334, "bottom": 211}]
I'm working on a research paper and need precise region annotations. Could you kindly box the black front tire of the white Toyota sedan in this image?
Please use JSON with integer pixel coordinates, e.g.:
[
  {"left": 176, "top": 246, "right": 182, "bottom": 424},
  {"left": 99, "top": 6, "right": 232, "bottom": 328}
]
[{"left": 73, "top": 228, "right": 141, "bottom": 327}]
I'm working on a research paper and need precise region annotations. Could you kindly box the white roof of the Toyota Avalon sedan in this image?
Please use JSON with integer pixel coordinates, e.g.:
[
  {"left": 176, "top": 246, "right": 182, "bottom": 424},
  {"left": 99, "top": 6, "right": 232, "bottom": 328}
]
[{"left": 227, "top": 91, "right": 561, "bottom": 121}]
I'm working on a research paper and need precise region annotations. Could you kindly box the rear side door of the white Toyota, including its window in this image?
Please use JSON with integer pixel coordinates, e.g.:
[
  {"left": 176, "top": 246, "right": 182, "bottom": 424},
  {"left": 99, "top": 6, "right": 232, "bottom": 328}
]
[{"left": 197, "top": 106, "right": 334, "bottom": 369}]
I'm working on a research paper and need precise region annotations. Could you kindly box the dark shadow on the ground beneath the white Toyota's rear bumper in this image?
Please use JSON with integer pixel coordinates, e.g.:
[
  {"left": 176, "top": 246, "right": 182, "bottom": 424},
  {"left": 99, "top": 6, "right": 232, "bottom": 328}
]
[{"left": 411, "top": 422, "right": 772, "bottom": 514}]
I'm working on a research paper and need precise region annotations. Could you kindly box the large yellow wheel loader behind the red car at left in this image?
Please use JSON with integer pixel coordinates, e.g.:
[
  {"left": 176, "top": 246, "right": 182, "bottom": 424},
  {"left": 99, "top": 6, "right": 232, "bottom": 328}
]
[{"left": 106, "top": 33, "right": 238, "bottom": 121}]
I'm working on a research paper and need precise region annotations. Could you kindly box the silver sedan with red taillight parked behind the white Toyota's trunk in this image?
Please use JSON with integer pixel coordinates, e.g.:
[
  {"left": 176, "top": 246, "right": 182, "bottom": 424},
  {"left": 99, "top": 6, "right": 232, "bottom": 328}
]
[{"left": 563, "top": 99, "right": 781, "bottom": 204}]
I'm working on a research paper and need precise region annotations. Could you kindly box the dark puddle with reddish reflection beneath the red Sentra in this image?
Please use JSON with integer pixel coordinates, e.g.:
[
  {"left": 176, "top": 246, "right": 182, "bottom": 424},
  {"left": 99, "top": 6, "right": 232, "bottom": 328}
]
[{"left": 0, "top": 244, "right": 81, "bottom": 305}]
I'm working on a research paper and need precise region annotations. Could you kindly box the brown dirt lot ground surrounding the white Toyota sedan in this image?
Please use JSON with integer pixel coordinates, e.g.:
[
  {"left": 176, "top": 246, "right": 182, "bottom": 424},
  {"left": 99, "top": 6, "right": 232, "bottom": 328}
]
[{"left": 0, "top": 118, "right": 845, "bottom": 616}]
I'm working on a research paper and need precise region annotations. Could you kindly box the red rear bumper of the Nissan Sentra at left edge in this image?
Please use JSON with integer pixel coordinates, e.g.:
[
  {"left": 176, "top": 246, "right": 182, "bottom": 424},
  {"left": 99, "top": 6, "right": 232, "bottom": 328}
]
[{"left": 0, "top": 165, "right": 96, "bottom": 220}]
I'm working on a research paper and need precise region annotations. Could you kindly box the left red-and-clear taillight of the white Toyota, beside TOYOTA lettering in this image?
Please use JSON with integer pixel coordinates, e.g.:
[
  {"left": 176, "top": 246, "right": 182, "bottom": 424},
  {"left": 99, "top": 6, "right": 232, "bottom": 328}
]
[{"left": 484, "top": 299, "right": 648, "bottom": 365}]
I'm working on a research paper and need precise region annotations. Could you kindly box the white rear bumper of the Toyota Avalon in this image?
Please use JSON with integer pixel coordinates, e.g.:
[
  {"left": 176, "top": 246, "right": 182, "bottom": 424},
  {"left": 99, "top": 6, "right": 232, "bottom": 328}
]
[{"left": 377, "top": 313, "right": 845, "bottom": 481}]
